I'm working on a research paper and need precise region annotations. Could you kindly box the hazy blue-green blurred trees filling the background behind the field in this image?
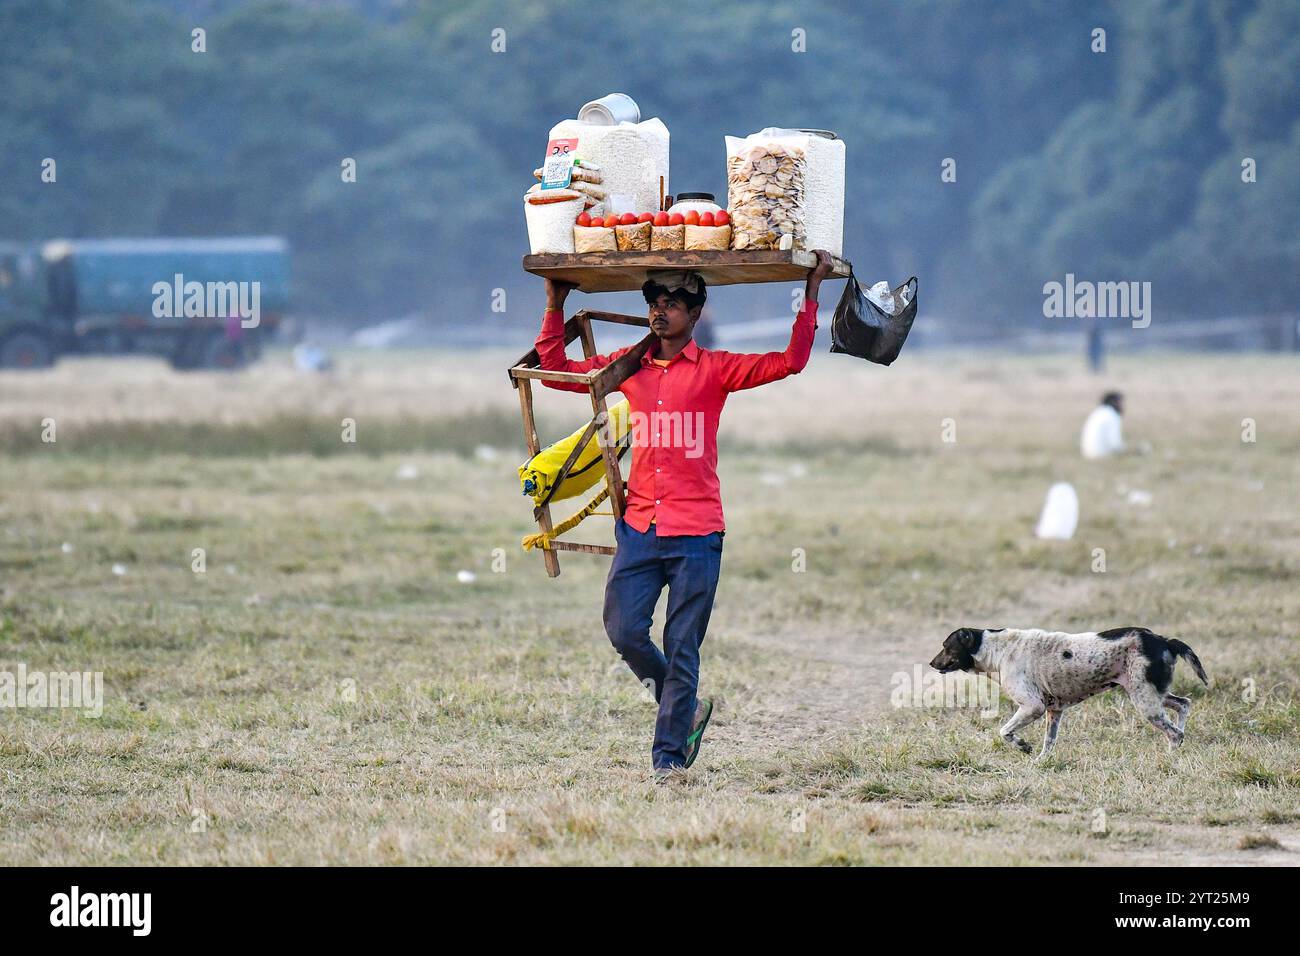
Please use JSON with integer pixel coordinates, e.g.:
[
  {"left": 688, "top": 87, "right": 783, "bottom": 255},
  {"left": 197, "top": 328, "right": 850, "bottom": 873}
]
[{"left": 0, "top": 0, "right": 1300, "bottom": 325}]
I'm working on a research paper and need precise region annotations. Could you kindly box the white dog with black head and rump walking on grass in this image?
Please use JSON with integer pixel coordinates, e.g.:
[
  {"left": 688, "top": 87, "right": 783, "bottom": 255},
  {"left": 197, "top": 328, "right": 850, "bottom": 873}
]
[{"left": 930, "top": 627, "right": 1210, "bottom": 757}]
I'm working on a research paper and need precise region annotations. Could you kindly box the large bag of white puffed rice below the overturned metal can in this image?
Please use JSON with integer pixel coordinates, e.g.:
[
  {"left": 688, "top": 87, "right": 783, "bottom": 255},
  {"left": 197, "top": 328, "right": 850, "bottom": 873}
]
[{"left": 550, "top": 117, "right": 672, "bottom": 212}]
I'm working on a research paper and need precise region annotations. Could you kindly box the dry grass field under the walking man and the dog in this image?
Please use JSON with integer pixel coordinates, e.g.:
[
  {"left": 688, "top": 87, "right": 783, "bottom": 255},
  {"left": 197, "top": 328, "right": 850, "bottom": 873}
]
[{"left": 0, "top": 345, "right": 1300, "bottom": 865}]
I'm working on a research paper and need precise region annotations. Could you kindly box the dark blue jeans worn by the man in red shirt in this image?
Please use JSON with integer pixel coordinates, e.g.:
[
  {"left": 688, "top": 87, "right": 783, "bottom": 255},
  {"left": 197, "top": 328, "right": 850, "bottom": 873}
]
[{"left": 605, "top": 518, "right": 725, "bottom": 769}]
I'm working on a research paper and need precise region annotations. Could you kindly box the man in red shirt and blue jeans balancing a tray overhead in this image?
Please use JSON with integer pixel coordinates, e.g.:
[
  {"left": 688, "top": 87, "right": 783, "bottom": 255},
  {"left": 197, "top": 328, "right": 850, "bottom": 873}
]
[{"left": 537, "top": 250, "right": 833, "bottom": 780}]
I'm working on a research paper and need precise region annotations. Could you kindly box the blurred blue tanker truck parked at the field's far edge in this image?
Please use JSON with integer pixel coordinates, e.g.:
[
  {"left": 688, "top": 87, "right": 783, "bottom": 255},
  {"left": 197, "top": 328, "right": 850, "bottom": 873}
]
[{"left": 0, "top": 237, "right": 290, "bottom": 369}]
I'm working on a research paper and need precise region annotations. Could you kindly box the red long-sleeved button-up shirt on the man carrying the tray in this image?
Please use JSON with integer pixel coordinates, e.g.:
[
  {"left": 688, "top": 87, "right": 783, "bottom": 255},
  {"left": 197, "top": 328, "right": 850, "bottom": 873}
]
[{"left": 537, "top": 302, "right": 816, "bottom": 537}]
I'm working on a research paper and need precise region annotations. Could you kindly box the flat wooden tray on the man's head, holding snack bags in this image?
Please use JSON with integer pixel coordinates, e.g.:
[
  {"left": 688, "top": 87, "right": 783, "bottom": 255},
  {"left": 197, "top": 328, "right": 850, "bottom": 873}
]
[{"left": 524, "top": 248, "right": 849, "bottom": 293}]
